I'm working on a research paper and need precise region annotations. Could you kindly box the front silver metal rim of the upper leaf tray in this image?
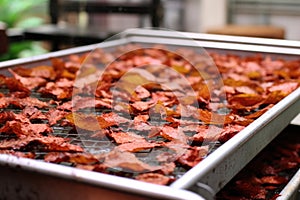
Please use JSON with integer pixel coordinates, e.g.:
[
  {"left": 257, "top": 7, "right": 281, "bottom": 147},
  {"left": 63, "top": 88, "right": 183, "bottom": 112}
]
[{"left": 0, "top": 154, "right": 204, "bottom": 200}]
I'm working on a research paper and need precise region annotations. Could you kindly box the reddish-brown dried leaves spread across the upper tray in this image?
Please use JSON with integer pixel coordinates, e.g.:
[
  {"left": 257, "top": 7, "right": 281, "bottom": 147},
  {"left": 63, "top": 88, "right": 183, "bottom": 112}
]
[{"left": 0, "top": 45, "right": 300, "bottom": 185}]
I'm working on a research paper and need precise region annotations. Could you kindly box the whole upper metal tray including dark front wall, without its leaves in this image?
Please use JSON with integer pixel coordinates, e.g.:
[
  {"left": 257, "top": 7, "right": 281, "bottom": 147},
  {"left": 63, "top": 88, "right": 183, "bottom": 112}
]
[{"left": 0, "top": 29, "right": 300, "bottom": 199}]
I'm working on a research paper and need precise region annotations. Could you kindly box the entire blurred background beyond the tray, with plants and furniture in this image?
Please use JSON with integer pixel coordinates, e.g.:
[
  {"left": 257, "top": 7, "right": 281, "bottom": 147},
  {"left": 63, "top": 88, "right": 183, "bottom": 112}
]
[{"left": 0, "top": 0, "right": 300, "bottom": 61}]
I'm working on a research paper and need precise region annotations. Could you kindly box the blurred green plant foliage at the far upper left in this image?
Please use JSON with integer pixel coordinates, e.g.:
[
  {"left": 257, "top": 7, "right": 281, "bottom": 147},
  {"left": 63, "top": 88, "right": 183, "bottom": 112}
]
[{"left": 0, "top": 0, "right": 48, "bottom": 60}]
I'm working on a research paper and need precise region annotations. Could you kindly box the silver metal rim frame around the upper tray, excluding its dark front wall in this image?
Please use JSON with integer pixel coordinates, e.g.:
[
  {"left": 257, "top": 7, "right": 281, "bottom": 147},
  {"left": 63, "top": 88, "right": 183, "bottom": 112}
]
[{"left": 0, "top": 29, "right": 300, "bottom": 199}]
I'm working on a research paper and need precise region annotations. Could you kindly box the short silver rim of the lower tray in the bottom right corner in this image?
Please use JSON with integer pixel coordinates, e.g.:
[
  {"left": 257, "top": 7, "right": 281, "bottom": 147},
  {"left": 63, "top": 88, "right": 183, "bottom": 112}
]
[{"left": 276, "top": 169, "right": 300, "bottom": 200}]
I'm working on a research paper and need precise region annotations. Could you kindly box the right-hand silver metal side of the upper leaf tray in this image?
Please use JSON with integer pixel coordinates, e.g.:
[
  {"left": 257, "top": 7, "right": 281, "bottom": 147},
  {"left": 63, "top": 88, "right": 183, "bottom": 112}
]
[{"left": 170, "top": 88, "right": 300, "bottom": 193}]
